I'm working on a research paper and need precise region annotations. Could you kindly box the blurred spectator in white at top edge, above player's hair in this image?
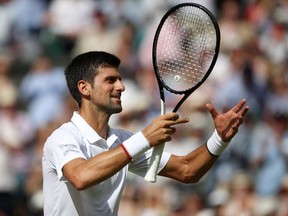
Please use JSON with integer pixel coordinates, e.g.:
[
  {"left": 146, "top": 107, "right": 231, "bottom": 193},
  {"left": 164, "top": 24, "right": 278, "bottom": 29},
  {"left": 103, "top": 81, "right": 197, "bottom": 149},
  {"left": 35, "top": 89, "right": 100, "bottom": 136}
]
[{"left": 44, "top": 0, "right": 95, "bottom": 62}]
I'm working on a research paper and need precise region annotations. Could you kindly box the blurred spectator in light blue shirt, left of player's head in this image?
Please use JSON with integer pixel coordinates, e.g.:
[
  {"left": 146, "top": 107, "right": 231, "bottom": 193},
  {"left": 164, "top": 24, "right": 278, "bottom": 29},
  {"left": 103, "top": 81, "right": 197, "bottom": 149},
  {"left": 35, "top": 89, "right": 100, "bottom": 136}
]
[{"left": 20, "top": 56, "right": 68, "bottom": 130}]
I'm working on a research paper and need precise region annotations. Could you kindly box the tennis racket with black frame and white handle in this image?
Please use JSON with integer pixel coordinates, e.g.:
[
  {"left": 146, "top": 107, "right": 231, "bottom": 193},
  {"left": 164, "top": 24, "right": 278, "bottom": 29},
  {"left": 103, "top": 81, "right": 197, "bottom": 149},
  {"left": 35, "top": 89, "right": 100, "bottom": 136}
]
[{"left": 145, "top": 3, "right": 220, "bottom": 182}]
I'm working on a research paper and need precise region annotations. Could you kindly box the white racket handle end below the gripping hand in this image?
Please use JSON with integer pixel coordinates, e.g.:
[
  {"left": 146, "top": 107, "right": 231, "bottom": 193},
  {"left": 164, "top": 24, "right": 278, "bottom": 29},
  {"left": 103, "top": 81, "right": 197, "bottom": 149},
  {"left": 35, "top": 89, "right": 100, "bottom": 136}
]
[{"left": 144, "top": 143, "right": 165, "bottom": 183}]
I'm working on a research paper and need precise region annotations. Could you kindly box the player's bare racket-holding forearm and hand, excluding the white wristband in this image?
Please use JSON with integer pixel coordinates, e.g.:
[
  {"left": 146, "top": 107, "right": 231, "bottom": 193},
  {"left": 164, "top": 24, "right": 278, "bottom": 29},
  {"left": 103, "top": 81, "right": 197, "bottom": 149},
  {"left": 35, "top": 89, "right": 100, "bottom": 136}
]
[{"left": 63, "top": 113, "right": 188, "bottom": 190}]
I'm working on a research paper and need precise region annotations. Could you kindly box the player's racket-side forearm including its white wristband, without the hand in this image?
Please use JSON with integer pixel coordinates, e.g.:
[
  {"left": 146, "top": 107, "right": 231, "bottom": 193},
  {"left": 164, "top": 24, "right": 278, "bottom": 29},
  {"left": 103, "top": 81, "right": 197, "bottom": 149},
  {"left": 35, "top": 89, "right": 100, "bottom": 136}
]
[{"left": 63, "top": 132, "right": 150, "bottom": 190}]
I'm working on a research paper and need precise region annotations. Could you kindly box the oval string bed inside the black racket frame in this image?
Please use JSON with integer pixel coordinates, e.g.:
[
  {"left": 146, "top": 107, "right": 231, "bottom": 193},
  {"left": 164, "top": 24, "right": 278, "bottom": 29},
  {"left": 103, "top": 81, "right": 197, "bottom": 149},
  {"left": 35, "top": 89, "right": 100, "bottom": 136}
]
[{"left": 156, "top": 7, "right": 216, "bottom": 91}]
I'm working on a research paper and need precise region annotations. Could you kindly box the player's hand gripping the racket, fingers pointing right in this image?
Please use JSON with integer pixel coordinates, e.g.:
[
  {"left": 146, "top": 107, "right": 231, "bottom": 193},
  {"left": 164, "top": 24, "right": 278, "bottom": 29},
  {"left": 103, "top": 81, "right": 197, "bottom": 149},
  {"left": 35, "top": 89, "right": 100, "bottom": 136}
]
[{"left": 142, "top": 113, "right": 189, "bottom": 146}]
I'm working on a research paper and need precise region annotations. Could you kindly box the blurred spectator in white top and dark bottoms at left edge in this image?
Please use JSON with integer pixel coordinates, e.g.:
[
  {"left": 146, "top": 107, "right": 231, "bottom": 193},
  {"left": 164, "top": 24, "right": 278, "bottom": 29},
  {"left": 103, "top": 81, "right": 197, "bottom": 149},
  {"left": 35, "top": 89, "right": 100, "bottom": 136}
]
[{"left": 0, "top": 67, "right": 33, "bottom": 216}]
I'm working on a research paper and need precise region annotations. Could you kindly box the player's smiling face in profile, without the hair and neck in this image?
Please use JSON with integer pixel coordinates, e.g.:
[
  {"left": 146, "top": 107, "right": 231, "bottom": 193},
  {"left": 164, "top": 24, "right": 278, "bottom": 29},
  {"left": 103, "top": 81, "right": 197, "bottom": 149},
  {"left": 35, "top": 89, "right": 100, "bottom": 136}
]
[{"left": 87, "top": 67, "right": 125, "bottom": 115}]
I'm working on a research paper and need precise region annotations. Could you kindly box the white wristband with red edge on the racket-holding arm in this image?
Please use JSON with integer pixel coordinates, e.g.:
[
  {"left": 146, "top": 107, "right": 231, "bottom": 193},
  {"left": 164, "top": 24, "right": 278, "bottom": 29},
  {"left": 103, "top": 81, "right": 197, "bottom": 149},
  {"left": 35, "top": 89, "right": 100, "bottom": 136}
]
[{"left": 122, "top": 131, "right": 151, "bottom": 159}]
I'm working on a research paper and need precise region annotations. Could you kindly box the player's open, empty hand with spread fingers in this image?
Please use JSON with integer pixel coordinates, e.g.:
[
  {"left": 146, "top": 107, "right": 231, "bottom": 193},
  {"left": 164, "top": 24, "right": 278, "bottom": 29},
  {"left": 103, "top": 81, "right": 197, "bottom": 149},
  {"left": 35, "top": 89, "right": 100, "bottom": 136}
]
[{"left": 206, "top": 99, "right": 249, "bottom": 142}]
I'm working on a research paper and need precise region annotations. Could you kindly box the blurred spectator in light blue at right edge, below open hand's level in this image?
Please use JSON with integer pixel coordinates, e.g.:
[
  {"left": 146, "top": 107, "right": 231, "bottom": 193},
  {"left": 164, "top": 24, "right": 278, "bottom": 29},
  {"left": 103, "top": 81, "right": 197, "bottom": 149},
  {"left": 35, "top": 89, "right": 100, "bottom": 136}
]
[{"left": 249, "top": 112, "right": 287, "bottom": 197}]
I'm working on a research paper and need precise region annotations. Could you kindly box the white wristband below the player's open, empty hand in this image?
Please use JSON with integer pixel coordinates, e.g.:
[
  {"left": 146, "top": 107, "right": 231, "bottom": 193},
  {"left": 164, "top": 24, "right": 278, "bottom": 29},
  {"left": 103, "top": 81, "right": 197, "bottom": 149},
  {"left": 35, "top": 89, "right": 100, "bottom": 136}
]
[{"left": 207, "top": 129, "right": 230, "bottom": 156}]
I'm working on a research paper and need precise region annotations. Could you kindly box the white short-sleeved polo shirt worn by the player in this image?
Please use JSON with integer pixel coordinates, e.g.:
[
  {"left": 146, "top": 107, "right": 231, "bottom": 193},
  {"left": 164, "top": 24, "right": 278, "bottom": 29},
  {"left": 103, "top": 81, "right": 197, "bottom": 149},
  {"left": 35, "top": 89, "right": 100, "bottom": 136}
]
[{"left": 42, "top": 112, "right": 170, "bottom": 216}]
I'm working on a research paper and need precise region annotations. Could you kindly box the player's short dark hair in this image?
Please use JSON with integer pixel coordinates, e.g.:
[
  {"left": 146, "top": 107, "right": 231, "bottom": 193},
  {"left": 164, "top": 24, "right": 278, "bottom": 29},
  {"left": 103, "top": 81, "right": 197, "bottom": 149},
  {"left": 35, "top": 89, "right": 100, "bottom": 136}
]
[{"left": 65, "top": 51, "right": 121, "bottom": 107}]
